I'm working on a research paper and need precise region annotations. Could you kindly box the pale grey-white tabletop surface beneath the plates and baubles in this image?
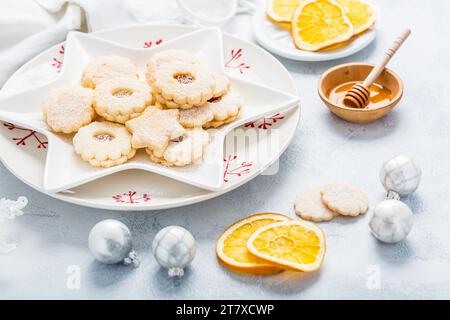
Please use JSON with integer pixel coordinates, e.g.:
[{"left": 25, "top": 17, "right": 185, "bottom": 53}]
[{"left": 0, "top": 0, "right": 450, "bottom": 299}]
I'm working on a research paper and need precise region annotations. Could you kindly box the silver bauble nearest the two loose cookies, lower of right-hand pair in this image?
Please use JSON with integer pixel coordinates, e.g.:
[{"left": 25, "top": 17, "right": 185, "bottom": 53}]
[{"left": 369, "top": 200, "right": 413, "bottom": 243}]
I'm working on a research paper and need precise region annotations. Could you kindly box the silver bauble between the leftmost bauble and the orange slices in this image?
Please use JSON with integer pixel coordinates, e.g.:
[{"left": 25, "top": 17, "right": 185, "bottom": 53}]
[{"left": 152, "top": 226, "right": 196, "bottom": 277}]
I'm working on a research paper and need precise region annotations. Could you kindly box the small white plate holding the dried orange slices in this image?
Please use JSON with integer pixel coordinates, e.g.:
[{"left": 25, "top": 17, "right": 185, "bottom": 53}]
[{"left": 252, "top": 9, "right": 377, "bottom": 61}]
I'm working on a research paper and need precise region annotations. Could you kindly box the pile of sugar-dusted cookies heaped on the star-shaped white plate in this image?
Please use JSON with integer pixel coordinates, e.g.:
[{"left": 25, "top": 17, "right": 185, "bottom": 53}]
[{"left": 43, "top": 50, "right": 242, "bottom": 167}]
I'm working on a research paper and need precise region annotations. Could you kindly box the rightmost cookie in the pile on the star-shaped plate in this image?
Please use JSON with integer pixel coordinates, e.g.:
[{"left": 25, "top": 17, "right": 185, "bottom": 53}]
[{"left": 203, "top": 89, "right": 243, "bottom": 128}]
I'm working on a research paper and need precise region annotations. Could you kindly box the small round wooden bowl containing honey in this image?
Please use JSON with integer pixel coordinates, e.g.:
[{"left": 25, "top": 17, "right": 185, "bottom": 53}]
[{"left": 318, "top": 62, "right": 403, "bottom": 123}]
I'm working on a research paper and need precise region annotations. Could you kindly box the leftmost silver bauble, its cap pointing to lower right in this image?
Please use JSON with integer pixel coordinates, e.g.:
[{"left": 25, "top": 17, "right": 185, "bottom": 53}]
[{"left": 88, "top": 219, "right": 138, "bottom": 266}]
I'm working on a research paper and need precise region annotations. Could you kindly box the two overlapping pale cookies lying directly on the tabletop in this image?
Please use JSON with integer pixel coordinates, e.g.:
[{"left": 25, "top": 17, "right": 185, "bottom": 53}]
[{"left": 294, "top": 182, "right": 369, "bottom": 222}]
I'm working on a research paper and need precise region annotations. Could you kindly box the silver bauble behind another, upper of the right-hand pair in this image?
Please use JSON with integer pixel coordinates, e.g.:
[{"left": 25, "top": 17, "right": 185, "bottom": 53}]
[{"left": 380, "top": 155, "right": 422, "bottom": 196}]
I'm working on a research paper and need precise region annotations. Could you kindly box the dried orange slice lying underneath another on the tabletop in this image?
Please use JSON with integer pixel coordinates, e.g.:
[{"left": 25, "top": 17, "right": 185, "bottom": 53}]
[{"left": 216, "top": 213, "right": 291, "bottom": 274}]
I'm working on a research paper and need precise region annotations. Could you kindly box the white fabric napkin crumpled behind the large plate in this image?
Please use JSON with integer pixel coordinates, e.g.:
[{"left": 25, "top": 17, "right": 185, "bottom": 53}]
[{"left": 0, "top": 0, "right": 182, "bottom": 87}]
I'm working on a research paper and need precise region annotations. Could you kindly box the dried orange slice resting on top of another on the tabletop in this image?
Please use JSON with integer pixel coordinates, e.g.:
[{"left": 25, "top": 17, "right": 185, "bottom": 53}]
[{"left": 247, "top": 220, "right": 326, "bottom": 272}]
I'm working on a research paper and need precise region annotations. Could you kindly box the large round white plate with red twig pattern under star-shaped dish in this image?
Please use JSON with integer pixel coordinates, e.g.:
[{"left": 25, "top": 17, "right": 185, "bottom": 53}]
[{"left": 0, "top": 25, "right": 300, "bottom": 211}]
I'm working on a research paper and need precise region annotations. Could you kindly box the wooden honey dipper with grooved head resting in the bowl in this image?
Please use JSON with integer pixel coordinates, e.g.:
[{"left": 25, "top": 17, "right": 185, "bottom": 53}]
[{"left": 344, "top": 29, "right": 411, "bottom": 109}]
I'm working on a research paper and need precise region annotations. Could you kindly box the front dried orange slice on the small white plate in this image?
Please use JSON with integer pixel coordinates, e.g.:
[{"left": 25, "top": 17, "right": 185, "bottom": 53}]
[{"left": 292, "top": 0, "right": 354, "bottom": 51}]
